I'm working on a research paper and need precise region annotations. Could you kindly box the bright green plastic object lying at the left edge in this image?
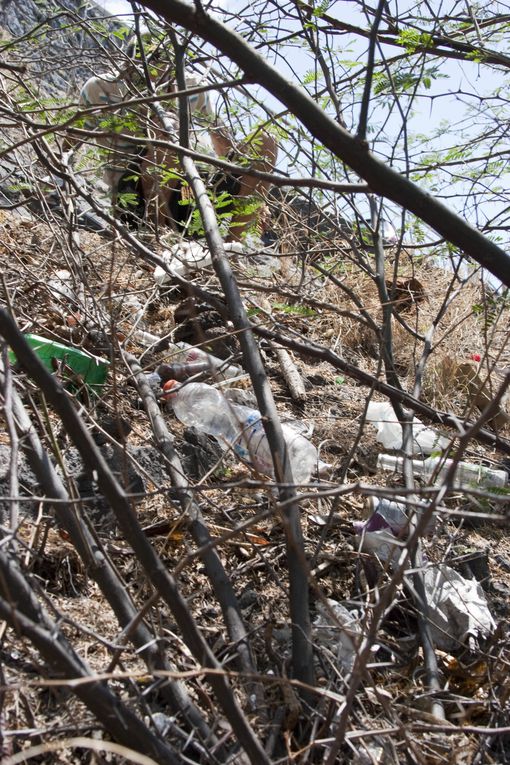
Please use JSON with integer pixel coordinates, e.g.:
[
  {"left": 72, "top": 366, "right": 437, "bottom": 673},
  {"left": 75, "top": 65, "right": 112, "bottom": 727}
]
[{"left": 9, "top": 335, "right": 110, "bottom": 394}]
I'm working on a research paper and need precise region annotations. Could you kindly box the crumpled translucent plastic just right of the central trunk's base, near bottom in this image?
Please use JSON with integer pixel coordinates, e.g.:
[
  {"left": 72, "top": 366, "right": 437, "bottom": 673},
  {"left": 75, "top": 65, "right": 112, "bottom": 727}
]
[{"left": 313, "top": 598, "right": 372, "bottom": 672}]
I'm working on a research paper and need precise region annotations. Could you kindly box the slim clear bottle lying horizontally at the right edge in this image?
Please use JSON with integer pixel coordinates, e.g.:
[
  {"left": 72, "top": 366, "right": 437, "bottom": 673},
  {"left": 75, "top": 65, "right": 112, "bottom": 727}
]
[{"left": 377, "top": 454, "right": 508, "bottom": 488}]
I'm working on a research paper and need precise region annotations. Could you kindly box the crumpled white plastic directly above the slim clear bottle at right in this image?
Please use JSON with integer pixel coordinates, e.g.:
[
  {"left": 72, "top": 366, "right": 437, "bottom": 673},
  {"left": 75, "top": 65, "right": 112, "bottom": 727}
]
[{"left": 366, "top": 401, "right": 449, "bottom": 454}]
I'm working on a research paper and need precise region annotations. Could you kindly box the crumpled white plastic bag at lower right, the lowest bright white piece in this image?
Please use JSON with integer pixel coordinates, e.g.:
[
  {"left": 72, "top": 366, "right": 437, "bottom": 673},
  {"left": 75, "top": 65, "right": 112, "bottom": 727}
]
[{"left": 414, "top": 563, "right": 496, "bottom": 651}]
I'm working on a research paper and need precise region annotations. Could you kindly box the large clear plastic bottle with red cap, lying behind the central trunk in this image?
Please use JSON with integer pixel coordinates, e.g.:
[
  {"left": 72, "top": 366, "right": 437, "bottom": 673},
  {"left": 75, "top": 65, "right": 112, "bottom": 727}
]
[{"left": 164, "top": 380, "right": 318, "bottom": 483}]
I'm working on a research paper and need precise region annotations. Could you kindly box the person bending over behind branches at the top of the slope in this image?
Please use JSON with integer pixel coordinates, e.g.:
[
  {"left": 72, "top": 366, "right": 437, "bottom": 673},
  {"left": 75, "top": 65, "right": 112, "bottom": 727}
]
[{"left": 64, "top": 35, "right": 278, "bottom": 246}]
